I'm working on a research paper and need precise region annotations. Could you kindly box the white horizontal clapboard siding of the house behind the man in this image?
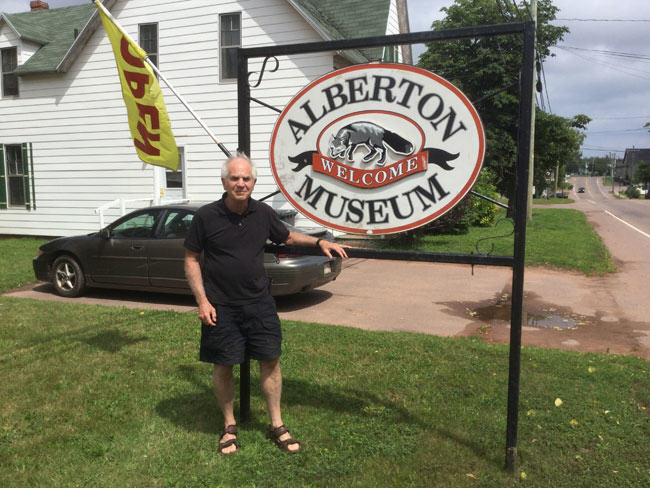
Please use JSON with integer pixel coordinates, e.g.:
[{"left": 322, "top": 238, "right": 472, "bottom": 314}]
[{"left": 0, "top": 0, "right": 332, "bottom": 236}]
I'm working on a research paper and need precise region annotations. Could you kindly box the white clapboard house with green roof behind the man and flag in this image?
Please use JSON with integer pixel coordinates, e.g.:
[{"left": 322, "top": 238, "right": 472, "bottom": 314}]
[{"left": 0, "top": 0, "right": 411, "bottom": 236}]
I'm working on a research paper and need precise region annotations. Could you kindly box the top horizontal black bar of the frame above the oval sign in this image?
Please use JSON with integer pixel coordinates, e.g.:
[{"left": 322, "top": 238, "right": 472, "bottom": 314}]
[{"left": 238, "top": 22, "right": 528, "bottom": 59}]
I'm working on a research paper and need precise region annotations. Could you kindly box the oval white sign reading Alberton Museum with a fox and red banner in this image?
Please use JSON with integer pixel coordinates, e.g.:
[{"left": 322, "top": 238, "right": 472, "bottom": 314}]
[{"left": 270, "top": 64, "right": 485, "bottom": 234}]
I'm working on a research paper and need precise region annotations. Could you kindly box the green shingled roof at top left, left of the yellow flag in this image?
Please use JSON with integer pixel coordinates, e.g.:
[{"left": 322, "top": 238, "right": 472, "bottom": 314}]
[{"left": 0, "top": 3, "right": 97, "bottom": 75}]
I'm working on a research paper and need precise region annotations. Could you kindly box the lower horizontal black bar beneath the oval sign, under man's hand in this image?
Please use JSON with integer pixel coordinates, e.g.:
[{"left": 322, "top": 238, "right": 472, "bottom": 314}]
[{"left": 265, "top": 244, "right": 513, "bottom": 267}]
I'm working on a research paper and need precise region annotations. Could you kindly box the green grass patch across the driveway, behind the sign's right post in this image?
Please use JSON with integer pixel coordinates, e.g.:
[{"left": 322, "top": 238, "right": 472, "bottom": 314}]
[{"left": 385, "top": 208, "right": 615, "bottom": 275}]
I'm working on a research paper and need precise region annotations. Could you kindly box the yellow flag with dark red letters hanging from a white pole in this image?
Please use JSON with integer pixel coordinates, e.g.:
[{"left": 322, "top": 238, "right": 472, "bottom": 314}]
[{"left": 95, "top": 0, "right": 178, "bottom": 171}]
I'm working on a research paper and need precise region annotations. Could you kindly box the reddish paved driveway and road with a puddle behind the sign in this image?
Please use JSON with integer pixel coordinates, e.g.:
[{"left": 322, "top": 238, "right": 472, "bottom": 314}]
[{"left": 5, "top": 179, "right": 650, "bottom": 360}]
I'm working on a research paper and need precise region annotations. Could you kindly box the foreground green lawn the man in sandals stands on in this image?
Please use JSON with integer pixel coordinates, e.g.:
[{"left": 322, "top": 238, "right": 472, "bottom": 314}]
[{"left": 0, "top": 297, "right": 650, "bottom": 488}]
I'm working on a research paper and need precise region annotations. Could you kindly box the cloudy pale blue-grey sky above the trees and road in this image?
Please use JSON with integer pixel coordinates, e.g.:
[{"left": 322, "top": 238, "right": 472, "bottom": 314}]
[{"left": 0, "top": 0, "right": 650, "bottom": 158}]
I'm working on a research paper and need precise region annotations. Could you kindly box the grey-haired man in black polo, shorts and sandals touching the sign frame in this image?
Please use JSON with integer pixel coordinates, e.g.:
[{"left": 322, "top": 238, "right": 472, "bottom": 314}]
[{"left": 185, "top": 155, "right": 347, "bottom": 454}]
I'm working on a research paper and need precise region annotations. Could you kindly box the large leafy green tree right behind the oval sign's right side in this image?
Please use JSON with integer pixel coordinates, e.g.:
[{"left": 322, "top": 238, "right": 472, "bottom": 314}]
[{"left": 418, "top": 0, "right": 568, "bottom": 200}]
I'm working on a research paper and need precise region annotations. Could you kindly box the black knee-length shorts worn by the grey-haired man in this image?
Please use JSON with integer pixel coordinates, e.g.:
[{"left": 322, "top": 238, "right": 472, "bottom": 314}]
[{"left": 199, "top": 295, "right": 282, "bottom": 366}]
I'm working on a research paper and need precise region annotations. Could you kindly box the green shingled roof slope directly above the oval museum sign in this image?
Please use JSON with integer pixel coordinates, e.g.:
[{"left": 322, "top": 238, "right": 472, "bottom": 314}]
[{"left": 289, "top": 0, "right": 390, "bottom": 63}]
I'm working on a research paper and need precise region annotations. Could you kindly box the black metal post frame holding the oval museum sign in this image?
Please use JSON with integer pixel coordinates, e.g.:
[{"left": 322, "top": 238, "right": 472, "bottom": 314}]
[{"left": 237, "top": 22, "right": 535, "bottom": 470}]
